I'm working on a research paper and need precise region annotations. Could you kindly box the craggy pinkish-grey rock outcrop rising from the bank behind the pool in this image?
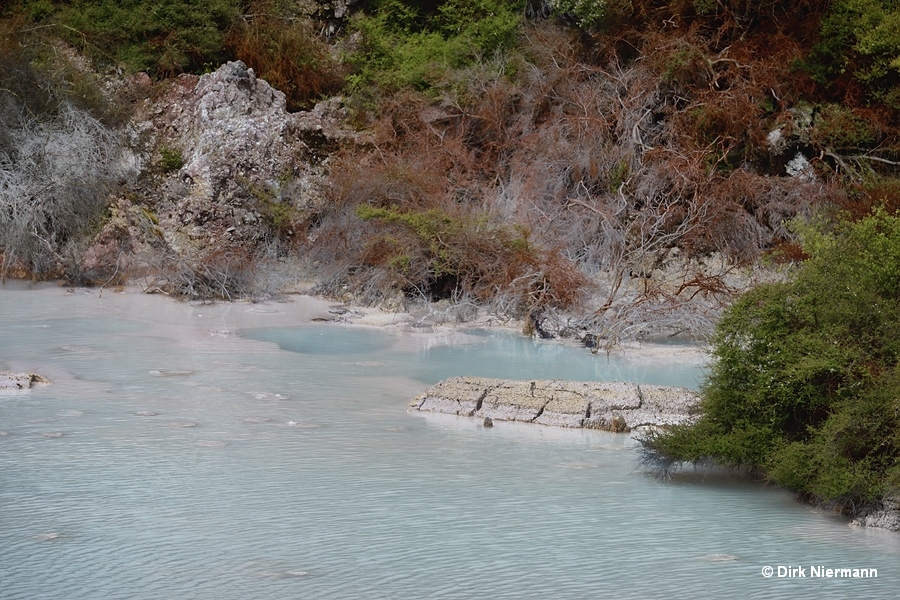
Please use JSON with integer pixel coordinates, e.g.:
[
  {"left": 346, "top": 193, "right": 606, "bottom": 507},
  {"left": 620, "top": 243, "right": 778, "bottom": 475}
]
[{"left": 82, "top": 61, "right": 366, "bottom": 282}]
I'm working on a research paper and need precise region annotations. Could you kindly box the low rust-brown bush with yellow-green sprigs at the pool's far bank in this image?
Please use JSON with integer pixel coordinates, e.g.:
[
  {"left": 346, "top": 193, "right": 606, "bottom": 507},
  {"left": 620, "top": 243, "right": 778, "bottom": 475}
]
[{"left": 313, "top": 135, "right": 584, "bottom": 311}]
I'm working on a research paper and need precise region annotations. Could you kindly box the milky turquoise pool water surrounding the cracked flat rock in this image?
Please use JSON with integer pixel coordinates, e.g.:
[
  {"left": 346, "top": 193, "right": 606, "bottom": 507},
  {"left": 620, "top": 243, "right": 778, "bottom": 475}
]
[{"left": 0, "top": 287, "right": 900, "bottom": 600}]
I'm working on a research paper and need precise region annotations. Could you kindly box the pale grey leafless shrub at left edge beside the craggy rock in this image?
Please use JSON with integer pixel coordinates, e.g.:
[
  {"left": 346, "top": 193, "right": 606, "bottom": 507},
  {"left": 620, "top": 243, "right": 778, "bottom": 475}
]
[{"left": 0, "top": 98, "right": 132, "bottom": 277}]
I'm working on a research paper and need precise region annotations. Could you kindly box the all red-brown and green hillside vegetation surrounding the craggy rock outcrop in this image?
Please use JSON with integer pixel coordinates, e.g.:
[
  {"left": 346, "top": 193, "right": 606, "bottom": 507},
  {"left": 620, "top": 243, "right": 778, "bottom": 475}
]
[{"left": 3, "top": 0, "right": 900, "bottom": 310}]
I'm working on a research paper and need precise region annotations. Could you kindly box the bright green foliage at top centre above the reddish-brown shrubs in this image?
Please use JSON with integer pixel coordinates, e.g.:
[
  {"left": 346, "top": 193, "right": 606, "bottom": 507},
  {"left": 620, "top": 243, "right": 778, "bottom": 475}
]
[{"left": 350, "top": 0, "right": 524, "bottom": 93}]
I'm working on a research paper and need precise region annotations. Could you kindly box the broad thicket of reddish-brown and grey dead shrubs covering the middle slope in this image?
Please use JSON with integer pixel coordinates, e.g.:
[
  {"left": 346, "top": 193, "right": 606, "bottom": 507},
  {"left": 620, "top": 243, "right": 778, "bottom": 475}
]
[{"left": 308, "top": 25, "right": 835, "bottom": 335}]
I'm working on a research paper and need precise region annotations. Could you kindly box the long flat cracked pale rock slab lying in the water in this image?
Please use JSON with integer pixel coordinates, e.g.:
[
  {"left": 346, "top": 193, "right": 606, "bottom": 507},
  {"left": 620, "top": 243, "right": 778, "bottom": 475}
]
[{"left": 407, "top": 377, "right": 699, "bottom": 432}]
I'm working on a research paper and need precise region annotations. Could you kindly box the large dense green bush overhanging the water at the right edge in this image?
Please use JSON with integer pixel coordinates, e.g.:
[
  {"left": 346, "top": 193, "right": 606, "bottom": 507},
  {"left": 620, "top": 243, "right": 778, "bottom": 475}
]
[{"left": 643, "top": 211, "right": 900, "bottom": 508}]
